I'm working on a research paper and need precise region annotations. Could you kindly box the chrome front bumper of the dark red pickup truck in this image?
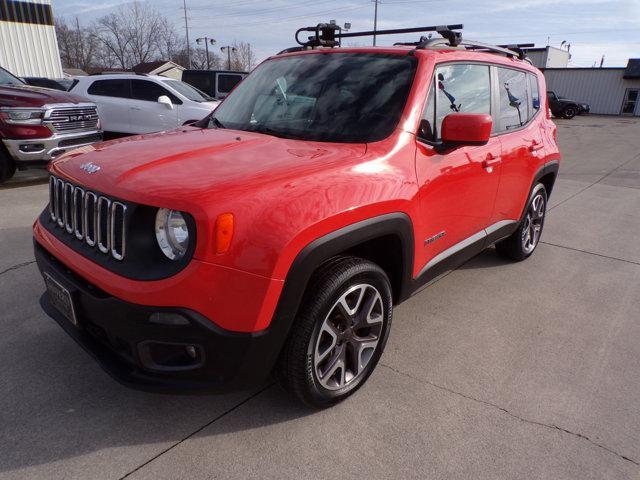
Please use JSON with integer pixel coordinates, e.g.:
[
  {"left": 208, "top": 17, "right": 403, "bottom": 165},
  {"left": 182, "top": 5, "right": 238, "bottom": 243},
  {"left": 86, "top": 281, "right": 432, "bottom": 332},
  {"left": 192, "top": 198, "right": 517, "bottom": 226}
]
[{"left": 3, "top": 130, "right": 102, "bottom": 164}]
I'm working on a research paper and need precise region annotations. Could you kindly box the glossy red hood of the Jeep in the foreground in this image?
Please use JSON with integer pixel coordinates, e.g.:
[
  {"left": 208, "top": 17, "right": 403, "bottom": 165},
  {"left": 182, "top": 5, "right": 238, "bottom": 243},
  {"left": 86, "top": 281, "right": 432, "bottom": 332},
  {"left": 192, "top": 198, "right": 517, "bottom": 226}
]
[{"left": 51, "top": 127, "right": 366, "bottom": 208}]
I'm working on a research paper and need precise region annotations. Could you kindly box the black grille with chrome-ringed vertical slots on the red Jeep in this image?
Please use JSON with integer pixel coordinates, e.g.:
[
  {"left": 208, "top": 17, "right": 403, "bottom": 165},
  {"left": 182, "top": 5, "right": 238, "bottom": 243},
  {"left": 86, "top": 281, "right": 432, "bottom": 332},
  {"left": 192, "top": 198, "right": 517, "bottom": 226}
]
[{"left": 49, "top": 176, "right": 127, "bottom": 260}]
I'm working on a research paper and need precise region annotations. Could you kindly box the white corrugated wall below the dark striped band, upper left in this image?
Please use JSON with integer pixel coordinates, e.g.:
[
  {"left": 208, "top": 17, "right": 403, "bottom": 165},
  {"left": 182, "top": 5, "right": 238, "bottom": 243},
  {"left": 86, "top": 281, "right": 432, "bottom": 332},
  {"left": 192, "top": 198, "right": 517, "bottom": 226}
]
[{"left": 0, "top": 0, "right": 63, "bottom": 78}]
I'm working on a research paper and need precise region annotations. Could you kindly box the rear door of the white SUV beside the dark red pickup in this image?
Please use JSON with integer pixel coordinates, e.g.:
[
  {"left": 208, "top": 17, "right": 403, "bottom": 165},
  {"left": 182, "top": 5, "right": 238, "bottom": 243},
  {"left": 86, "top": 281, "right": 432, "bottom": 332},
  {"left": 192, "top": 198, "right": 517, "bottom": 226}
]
[{"left": 87, "top": 78, "right": 132, "bottom": 133}]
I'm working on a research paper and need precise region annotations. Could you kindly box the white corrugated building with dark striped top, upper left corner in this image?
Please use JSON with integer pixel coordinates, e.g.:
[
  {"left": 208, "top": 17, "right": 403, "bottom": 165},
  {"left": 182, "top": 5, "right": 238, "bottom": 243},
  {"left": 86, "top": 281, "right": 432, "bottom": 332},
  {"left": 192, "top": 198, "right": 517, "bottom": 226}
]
[{"left": 0, "top": 0, "right": 63, "bottom": 78}]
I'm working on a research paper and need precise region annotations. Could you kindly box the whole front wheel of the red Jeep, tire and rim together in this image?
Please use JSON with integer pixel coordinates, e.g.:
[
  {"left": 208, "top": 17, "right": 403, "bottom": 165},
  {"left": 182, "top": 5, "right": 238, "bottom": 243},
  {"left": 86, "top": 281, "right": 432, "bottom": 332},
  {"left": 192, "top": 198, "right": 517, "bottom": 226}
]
[{"left": 275, "top": 257, "right": 393, "bottom": 408}]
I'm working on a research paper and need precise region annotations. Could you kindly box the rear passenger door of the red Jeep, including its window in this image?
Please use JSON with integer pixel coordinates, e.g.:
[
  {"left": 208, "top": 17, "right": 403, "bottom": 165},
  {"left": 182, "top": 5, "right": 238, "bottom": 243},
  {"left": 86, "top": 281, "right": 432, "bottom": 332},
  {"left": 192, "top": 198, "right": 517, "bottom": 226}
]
[{"left": 492, "top": 67, "right": 545, "bottom": 223}]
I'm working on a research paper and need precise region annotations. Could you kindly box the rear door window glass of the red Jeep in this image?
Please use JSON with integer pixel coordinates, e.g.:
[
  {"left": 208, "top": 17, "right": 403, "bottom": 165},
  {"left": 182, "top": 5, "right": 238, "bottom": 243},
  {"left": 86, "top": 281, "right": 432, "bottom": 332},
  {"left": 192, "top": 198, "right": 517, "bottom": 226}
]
[{"left": 498, "top": 68, "right": 529, "bottom": 132}]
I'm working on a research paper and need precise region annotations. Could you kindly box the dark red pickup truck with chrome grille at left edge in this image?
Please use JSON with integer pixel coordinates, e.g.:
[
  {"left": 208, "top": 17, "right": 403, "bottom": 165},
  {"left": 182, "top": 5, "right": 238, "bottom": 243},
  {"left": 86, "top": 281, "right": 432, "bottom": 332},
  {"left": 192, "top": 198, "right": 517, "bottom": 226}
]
[{"left": 0, "top": 68, "right": 102, "bottom": 184}]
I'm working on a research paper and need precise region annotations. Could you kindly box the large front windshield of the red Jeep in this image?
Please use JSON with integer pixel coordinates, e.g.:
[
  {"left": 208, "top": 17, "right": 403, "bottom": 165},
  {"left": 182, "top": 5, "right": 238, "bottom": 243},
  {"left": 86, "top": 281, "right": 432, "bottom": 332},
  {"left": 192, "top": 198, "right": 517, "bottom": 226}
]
[{"left": 208, "top": 53, "right": 417, "bottom": 143}]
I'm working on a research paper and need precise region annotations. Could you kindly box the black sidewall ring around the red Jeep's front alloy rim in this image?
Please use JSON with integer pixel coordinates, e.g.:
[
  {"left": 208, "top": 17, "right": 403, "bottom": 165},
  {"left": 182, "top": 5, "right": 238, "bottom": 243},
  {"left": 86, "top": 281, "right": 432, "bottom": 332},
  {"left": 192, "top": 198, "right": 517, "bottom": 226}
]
[{"left": 305, "top": 265, "right": 393, "bottom": 405}]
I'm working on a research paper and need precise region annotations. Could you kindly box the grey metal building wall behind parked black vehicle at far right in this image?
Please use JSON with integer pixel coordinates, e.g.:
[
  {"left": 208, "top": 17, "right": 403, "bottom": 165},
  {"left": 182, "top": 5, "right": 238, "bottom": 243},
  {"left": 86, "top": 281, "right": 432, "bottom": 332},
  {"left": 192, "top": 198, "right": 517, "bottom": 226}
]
[{"left": 544, "top": 68, "right": 640, "bottom": 115}]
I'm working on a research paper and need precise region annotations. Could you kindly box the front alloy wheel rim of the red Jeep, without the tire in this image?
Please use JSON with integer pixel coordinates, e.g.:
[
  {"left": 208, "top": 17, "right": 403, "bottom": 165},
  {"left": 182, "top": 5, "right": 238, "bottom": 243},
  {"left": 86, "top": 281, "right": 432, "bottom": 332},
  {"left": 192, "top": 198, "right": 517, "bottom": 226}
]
[{"left": 313, "top": 284, "right": 384, "bottom": 390}]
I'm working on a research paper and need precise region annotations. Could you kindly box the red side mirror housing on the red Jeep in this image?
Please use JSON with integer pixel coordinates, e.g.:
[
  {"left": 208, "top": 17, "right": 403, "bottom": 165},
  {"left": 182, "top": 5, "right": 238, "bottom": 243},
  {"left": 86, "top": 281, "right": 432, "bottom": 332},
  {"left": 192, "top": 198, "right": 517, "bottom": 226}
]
[{"left": 440, "top": 113, "right": 493, "bottom": 147}]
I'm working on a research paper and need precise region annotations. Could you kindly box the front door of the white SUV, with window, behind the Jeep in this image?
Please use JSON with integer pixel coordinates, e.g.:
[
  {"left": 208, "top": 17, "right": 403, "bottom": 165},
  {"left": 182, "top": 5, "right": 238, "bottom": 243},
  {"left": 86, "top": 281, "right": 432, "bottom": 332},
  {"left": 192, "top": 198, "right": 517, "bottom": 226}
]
[{"left": 130, "top": 79, "right": 182, "bottom": 133}]
